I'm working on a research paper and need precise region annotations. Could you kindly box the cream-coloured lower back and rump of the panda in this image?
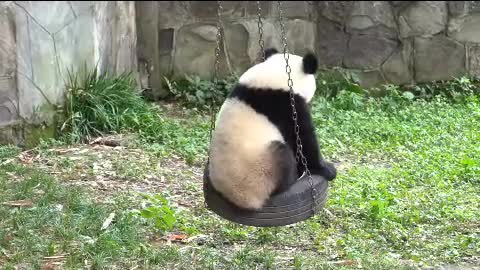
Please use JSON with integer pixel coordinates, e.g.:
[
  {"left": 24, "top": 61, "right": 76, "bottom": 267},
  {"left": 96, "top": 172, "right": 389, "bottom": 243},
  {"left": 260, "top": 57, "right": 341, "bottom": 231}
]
[{"left": 209, "top": 99, "right": 294, "bottom": 208}]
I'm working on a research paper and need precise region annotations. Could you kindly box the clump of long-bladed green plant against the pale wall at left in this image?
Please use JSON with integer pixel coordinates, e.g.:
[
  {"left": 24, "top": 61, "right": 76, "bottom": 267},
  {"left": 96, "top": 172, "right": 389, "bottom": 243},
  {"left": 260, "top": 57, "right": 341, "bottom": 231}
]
[{"left": 59, "top": 66, "right": 157, "bottom": 142}]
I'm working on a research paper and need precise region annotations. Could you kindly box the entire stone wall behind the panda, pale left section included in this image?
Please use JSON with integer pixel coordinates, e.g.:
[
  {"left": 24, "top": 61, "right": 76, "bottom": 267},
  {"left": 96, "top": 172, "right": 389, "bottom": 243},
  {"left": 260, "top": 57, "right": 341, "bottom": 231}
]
[{"left": 0, "top": 1, "right": 480, "bottom": 142}]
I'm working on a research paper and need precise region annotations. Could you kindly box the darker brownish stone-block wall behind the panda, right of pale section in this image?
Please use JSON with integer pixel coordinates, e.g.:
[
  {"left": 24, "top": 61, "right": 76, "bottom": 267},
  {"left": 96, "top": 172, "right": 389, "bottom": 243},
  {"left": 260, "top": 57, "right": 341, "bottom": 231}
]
[{"left": 136, "top": 1, "right": 480, "bottom": 96}]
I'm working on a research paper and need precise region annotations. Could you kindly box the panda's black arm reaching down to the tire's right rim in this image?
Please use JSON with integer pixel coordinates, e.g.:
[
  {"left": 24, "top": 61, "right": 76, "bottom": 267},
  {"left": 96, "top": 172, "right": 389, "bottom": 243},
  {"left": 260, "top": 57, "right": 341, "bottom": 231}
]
[{"left": 297, "top": 103, "right": 337, "bottom": 180}]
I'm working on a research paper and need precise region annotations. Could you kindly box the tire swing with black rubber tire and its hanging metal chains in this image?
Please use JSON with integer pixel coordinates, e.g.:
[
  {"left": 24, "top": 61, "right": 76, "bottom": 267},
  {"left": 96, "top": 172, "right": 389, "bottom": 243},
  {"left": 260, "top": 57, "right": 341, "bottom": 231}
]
[{"left": 203, "top": 1, "right": 328, "bottom": 227}]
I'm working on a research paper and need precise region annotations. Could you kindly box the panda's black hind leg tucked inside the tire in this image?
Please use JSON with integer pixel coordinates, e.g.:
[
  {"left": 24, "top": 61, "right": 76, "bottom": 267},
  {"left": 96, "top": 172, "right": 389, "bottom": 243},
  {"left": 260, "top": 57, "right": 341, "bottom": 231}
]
[{"left": 270, "top": 141, "right": 297, "bottom": 193}]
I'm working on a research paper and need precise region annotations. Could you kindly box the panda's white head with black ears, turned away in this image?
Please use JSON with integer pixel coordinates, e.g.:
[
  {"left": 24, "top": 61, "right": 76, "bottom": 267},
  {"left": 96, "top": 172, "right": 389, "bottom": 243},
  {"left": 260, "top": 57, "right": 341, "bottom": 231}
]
[{"left": 239, "top": 48, "right": 318, "bottom": 102}]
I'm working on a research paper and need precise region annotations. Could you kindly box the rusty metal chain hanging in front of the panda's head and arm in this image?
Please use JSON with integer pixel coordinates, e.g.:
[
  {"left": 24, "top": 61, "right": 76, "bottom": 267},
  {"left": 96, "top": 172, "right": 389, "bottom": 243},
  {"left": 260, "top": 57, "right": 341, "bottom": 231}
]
[{"left": 277, "top": 1, "right": 317, "bottom": 214}]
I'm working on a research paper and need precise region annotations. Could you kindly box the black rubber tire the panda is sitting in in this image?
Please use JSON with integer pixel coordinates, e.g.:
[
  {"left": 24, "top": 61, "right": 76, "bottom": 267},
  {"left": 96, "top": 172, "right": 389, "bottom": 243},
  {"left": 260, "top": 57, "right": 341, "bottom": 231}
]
[{"left": 203, "top": 168, "right": 328, "bottom": 227}]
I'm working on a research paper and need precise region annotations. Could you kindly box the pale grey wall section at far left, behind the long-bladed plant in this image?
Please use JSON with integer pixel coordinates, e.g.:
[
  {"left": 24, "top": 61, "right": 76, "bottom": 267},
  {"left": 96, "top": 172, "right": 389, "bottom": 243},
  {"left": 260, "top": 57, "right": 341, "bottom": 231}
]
[{"left": 0, "top": 1, "right": 137, "bottom": 146}]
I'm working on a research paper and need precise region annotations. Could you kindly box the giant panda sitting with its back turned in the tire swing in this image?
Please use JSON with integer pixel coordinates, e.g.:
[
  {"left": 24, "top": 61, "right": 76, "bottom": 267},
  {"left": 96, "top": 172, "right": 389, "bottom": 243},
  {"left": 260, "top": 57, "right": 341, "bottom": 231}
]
[{"left": 207, "top": 48, "right": 337, "bottom": 210}]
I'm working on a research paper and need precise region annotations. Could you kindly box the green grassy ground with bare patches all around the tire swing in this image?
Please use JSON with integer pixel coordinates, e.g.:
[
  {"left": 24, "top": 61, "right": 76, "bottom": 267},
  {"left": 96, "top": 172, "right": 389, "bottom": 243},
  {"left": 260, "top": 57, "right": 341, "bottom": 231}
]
[{"left": 0, "top": 70, "right": 480, "bottom": 269}]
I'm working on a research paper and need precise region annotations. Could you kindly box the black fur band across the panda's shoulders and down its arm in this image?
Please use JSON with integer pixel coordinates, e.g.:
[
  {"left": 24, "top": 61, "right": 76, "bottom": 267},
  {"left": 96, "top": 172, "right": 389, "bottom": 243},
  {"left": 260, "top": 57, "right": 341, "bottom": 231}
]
[{"left": 229, "top": 84, "right": 336, "bottom": 180}]
